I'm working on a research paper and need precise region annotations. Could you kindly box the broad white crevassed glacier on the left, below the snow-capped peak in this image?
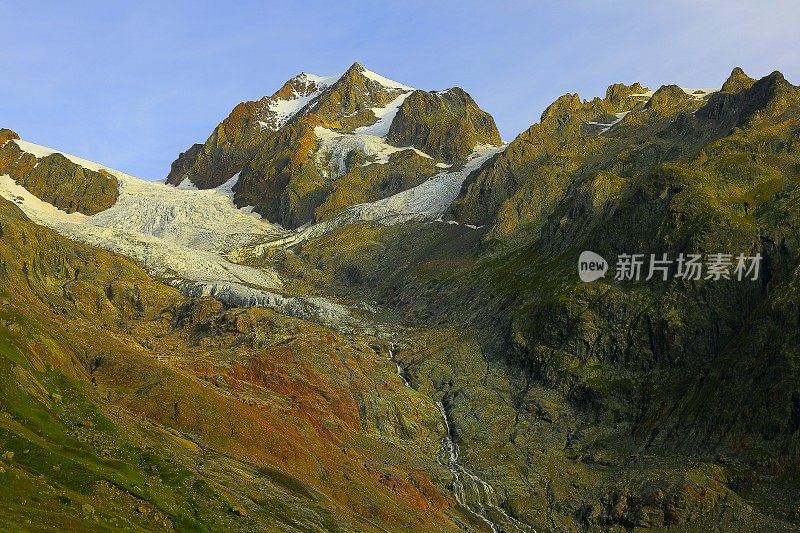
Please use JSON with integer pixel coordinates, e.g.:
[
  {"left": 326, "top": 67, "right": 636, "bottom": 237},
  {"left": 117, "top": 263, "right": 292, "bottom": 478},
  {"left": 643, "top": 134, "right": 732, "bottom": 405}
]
[{"left": 0, "top": 141, "right": 285, "bottom": 288}]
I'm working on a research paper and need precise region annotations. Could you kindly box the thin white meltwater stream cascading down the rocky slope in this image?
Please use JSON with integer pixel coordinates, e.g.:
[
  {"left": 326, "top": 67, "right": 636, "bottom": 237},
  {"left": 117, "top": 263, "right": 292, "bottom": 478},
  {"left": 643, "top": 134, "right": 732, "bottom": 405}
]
[{"left": 389, "top": 346, "right": 535, "bottom": 533}]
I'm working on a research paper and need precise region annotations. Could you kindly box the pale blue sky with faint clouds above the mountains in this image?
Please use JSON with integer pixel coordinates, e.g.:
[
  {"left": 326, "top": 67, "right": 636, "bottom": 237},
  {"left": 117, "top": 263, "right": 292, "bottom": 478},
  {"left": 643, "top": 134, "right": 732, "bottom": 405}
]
[{"left": 0, "top": 0, "right": 800, "bottom": 179}]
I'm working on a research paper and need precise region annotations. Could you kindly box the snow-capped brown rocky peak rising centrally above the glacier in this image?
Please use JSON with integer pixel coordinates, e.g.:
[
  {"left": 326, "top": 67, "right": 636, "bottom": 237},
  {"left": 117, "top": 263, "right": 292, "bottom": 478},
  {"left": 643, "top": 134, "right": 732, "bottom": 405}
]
[{"left": 167, "top": 63, "right": 500, "bottom": 228}]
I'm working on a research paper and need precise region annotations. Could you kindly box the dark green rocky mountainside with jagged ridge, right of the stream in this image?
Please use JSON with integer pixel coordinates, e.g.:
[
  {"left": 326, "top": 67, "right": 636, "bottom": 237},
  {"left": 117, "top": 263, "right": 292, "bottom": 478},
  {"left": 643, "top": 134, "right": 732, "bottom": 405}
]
[{"left": 253, "top": 68, "right": 800, "bottom": 531}]
